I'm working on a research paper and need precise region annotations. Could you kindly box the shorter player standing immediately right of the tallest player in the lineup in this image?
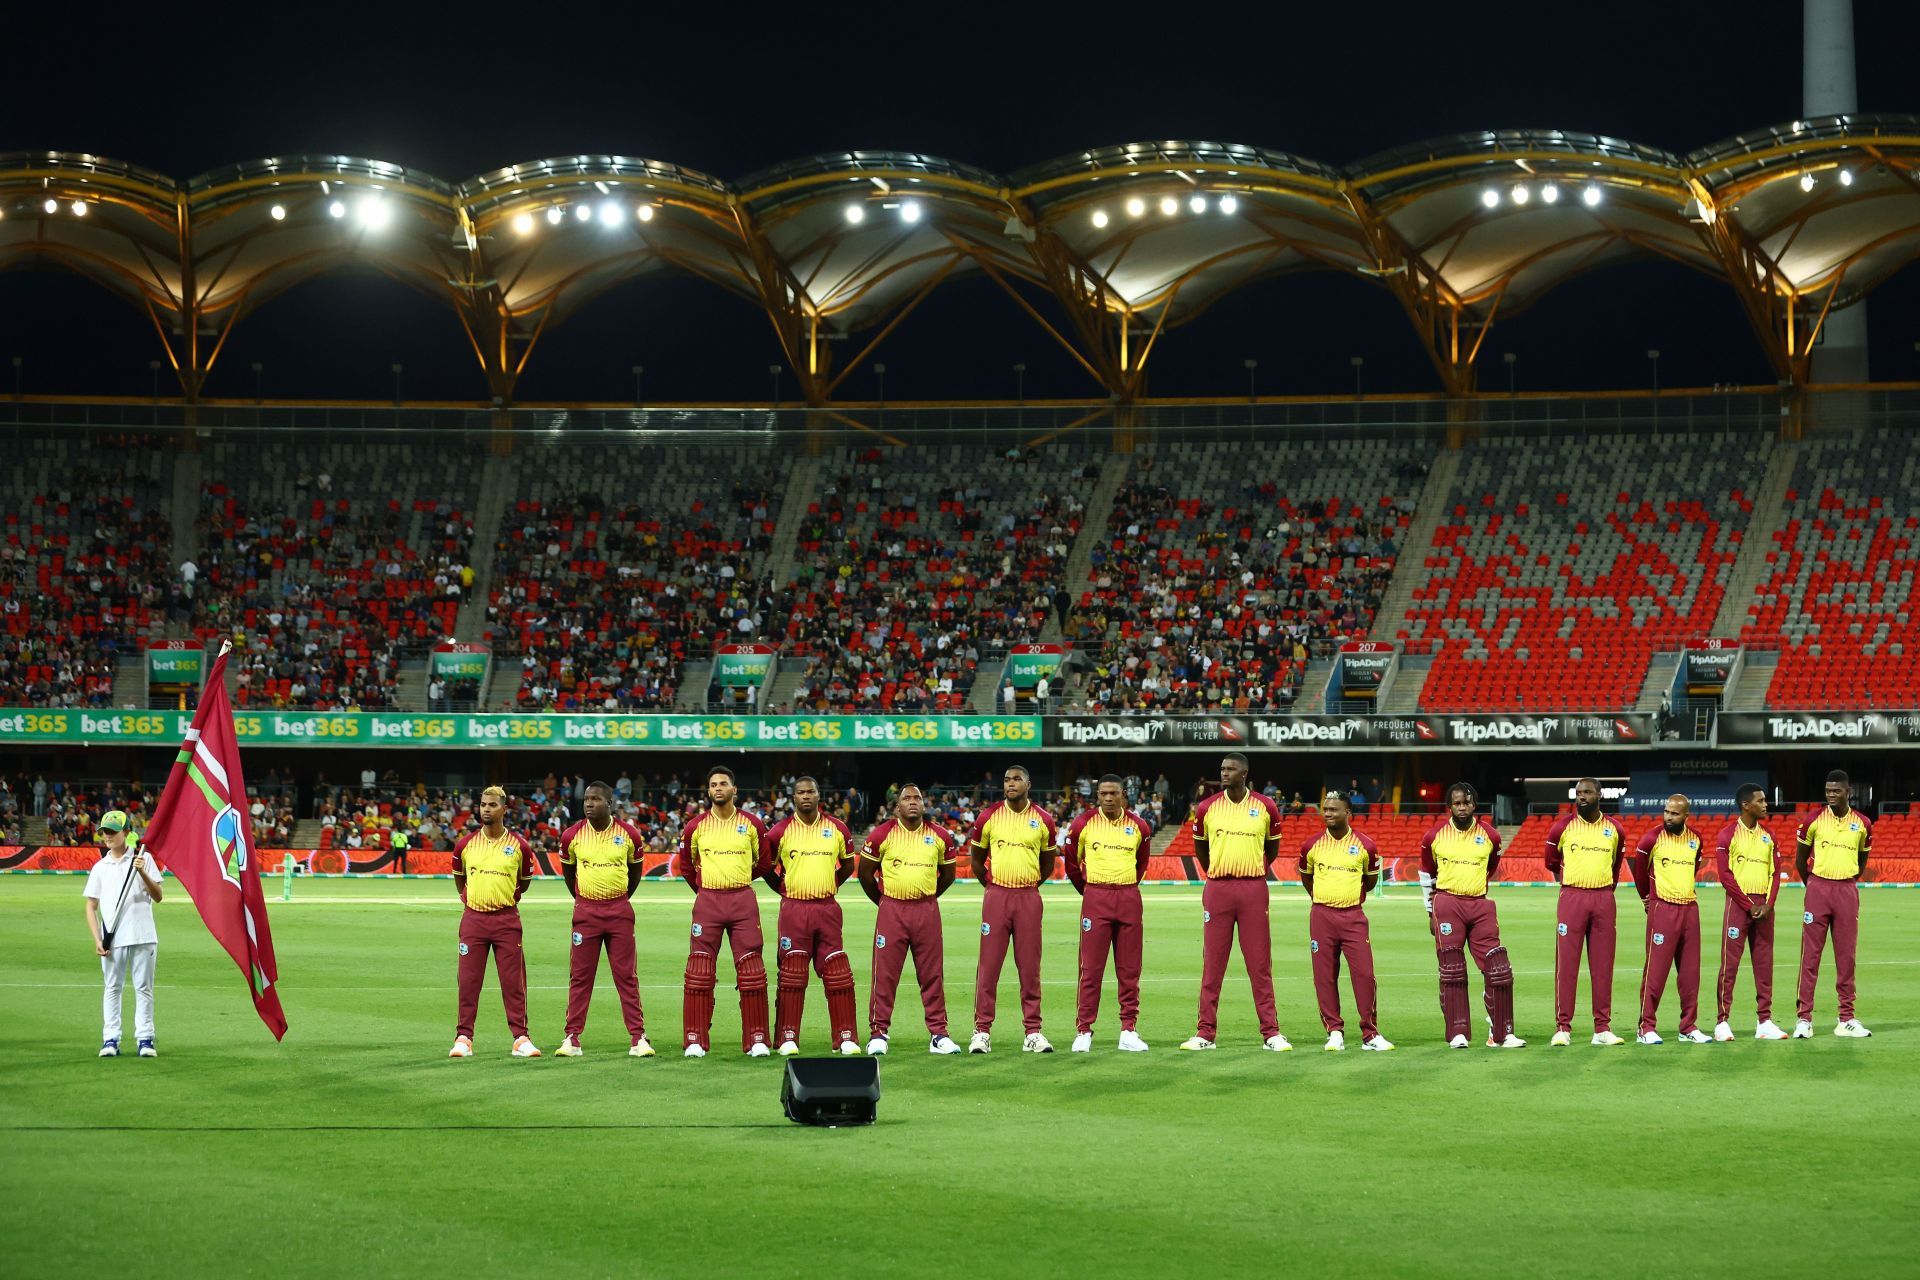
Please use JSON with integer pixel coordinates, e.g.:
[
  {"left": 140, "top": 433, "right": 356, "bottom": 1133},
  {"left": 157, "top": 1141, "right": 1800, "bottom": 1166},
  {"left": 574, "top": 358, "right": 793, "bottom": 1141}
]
[{"left": 1300, "top": 791, "right": 1394, "bottom": 1054}]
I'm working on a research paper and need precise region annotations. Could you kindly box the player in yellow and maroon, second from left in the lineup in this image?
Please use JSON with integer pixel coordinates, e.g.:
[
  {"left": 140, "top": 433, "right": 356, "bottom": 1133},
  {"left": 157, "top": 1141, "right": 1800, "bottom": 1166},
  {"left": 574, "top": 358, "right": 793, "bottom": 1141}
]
[{"left": 553, "top": 783, "right": 653, "bottom": 1057}]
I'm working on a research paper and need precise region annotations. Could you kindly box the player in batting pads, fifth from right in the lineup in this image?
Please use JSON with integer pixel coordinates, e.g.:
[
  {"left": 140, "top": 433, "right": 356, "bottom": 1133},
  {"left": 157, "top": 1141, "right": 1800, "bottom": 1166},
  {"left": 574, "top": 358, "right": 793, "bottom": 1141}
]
[{"left": 1421, "top": 783, "right": 1526, "bottom": 1050}]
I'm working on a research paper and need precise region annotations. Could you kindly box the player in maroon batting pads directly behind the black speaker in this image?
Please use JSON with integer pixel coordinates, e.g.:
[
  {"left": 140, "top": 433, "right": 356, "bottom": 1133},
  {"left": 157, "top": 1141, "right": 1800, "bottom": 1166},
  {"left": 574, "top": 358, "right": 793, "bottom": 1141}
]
[{"left": 760, "top": 777, "right": 860, "bottom": 1057}]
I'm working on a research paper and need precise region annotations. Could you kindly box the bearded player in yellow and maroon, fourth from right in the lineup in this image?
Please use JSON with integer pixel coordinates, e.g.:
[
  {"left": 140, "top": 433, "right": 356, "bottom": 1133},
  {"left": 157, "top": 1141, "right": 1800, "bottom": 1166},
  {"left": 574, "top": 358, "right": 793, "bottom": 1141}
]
[{"left": 1546, "top": 777, "right": 1626, "bottom": 1050}]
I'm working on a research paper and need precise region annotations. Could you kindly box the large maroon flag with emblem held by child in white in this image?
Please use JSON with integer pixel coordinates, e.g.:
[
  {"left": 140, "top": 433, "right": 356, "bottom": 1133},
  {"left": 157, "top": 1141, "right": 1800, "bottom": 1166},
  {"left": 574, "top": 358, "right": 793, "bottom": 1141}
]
[{"left": 140, "top": 645, "right": 286, "bottom": 1040}]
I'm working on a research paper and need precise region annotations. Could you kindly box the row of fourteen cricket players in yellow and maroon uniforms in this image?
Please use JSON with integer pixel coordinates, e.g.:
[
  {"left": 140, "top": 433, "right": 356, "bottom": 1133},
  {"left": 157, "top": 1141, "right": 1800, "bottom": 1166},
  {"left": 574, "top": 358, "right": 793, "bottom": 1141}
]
[{"left": 449, "top": 752, "right": 1872, "bottom": 1057}]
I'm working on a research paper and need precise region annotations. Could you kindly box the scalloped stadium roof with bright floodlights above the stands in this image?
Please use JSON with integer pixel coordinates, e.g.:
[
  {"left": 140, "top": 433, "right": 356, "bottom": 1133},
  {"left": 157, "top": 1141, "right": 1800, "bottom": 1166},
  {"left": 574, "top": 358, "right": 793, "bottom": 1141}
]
[{"left": 0, "top": 115, "right": 1920, "bottom": 403}]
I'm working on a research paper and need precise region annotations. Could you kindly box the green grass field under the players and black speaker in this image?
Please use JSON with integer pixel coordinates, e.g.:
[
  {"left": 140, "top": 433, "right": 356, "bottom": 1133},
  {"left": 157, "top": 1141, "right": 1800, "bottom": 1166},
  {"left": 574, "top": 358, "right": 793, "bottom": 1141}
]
[{"left": 0, "top": 877, "right": 1920, "bottom": 1276}]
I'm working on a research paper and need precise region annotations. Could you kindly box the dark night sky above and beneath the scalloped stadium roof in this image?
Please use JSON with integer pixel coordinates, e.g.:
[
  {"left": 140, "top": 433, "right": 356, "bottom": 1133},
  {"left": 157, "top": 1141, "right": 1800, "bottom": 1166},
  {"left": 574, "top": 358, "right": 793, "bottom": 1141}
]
[{"left": 0, "top": 0, "right": 1920, "bottom": 399}]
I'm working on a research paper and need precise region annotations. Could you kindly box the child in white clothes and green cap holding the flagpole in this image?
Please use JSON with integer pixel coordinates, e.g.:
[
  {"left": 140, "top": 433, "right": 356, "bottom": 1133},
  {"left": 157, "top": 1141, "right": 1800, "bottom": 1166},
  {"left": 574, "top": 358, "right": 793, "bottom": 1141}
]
[{"left": 83, "top": 810, "right": 161, "bottom": 1057}]
